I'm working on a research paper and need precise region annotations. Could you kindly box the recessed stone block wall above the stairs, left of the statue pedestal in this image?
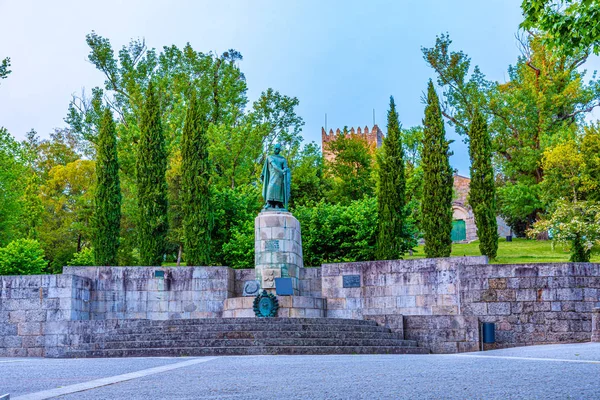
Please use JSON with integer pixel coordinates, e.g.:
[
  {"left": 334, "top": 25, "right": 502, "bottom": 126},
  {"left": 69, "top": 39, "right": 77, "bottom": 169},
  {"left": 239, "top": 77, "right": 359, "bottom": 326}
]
[{"left": 63, "top": 267, "right": 235, "bottom": 320}]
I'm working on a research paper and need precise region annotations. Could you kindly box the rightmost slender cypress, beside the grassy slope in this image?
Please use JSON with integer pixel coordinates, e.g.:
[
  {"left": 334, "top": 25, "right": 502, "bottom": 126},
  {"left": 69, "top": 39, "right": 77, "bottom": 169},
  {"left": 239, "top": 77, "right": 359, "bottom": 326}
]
[{"left": 469, "top": 110, "right": 498, "bottom": 259}]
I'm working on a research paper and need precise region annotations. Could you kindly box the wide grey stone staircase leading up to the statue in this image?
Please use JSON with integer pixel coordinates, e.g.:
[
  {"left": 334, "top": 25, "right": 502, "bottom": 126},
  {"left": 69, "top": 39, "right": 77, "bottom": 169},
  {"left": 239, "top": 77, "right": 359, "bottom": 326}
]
[{"left": 58, "top": 318, "right": 429, "bottom": 357}]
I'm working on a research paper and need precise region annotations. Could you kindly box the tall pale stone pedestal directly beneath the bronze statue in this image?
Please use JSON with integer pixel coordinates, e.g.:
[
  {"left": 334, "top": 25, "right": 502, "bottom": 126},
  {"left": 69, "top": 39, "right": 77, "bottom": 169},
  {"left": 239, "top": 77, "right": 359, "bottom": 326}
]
[{"left": 254, "top": 211, "right": 304, "bottom": 295}]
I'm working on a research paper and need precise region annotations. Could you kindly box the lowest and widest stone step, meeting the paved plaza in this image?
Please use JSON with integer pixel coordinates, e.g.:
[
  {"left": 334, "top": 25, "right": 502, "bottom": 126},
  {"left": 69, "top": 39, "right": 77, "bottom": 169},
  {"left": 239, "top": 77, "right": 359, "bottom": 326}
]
[{"left": 64, "top": 346, "right": 429, "bottom": 358}]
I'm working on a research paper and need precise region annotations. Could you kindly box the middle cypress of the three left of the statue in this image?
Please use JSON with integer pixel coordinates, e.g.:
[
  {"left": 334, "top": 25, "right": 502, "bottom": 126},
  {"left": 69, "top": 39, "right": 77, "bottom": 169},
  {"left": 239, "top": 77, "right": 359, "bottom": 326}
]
[{"left": 136, "top": 81, "right": 168, "bottom": 265}]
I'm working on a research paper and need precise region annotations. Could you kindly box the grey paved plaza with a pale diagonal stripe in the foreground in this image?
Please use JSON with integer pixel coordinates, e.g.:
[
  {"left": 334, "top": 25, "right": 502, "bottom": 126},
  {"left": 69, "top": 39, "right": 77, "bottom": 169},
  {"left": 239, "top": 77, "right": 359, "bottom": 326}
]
[{"left": 0, "top": 343, "right": 600, "bottom": 400}]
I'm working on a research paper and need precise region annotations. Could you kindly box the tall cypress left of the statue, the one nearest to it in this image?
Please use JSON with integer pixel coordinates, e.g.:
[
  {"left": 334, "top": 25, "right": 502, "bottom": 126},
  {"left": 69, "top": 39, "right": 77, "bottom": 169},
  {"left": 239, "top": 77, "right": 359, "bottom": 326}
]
[{"left": 181, "top": 89, "right": 211, "bottom": 265}]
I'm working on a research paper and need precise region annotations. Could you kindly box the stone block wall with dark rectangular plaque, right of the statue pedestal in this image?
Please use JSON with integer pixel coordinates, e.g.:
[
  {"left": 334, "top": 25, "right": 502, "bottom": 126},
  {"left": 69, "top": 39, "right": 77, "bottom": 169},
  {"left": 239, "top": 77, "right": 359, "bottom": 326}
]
[{"left": 321, "top": 257, "right": 487, "bottom": 319}]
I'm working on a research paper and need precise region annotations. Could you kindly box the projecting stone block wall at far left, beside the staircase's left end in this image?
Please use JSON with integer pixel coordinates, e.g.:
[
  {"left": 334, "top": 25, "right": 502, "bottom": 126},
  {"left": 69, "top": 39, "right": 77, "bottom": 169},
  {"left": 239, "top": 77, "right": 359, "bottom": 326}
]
[{"left": 0, "top": 275, "right": 91, "bottom": 357}]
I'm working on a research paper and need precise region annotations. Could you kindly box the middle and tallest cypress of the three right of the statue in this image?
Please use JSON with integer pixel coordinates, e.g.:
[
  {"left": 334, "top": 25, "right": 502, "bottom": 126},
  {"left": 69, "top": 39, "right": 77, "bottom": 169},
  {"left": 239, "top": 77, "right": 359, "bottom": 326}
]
[{"left": 421, "top": 80, "right": 453, "bottom": 258}]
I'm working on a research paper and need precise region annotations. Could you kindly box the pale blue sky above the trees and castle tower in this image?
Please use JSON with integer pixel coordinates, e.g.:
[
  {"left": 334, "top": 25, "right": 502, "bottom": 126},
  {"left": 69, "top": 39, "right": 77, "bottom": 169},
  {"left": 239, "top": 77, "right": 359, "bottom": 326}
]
[{"left": 0, "top": 0, "right": 600, "bottom": 175}]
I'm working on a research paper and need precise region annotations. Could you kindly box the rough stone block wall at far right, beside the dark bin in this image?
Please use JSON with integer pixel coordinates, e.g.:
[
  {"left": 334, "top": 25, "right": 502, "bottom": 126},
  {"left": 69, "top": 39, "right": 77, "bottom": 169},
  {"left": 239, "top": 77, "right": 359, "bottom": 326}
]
[{"left": 460, "top": 263, "right": 600, "bottom": 347}]
